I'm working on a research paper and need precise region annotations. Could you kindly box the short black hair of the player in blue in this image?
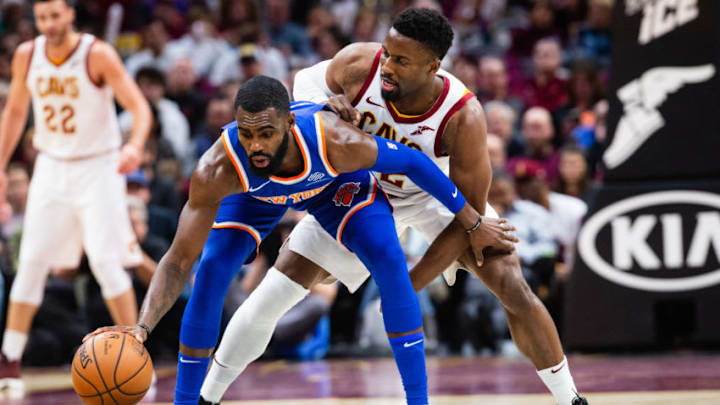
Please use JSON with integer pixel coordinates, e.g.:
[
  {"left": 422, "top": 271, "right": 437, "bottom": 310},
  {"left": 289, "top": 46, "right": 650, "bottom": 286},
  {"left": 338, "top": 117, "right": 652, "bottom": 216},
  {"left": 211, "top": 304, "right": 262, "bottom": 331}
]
[{"left": 235, "top": 76, "right": 290, "bottom": 115}]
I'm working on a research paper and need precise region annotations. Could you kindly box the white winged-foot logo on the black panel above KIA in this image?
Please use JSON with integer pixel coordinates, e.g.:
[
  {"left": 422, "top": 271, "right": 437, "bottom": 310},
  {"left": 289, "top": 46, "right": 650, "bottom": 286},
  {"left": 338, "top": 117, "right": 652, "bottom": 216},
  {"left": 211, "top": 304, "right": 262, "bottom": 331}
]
[{"left": 603, "top": 64, "right": 715, "bottom": 169}]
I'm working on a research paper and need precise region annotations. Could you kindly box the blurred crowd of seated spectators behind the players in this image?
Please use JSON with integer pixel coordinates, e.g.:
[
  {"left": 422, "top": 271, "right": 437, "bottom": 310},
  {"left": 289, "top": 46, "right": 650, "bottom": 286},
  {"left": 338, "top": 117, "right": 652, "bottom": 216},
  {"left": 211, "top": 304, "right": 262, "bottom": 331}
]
[{"left": 0, "top": 0, "right": 613, "bottom": 365}]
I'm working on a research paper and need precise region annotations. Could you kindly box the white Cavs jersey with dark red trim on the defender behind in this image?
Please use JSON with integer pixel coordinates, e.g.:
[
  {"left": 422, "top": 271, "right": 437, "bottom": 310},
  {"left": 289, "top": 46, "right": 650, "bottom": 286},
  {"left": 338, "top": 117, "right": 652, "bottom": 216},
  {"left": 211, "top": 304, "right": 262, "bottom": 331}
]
[{"left": 352, "top": 50, "right": 474, "bottom": 197}]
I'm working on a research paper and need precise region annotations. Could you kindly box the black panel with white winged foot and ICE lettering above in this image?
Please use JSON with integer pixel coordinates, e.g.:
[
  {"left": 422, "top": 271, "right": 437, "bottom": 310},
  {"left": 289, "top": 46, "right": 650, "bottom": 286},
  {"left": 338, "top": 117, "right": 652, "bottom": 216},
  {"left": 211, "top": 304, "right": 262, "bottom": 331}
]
[{"left": 602, "top": 0, "right": 720, "bottom": 182}]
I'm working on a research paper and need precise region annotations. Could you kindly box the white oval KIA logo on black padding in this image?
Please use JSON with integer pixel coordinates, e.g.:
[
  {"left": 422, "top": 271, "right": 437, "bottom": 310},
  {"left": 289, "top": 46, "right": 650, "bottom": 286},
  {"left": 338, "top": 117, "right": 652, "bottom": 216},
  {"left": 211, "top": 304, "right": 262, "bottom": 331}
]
[{"left": 578, "top": 191, "right": 720, "bottom": 292}]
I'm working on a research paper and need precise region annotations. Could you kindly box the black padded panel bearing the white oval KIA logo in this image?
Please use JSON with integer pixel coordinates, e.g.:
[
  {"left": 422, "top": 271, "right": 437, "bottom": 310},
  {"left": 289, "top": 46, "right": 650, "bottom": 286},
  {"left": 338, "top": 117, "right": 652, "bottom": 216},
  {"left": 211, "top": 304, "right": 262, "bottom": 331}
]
[{"left": 565, "top": 181, "right": 720, "bottom": 349}]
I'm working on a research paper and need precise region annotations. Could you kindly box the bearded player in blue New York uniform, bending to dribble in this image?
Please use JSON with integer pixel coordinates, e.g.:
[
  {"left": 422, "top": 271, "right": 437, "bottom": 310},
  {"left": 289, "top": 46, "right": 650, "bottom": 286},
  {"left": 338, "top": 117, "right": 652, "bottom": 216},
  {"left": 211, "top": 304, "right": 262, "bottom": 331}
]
[{"left": 88, "top": 76, "right": 516, "bottom": 405}]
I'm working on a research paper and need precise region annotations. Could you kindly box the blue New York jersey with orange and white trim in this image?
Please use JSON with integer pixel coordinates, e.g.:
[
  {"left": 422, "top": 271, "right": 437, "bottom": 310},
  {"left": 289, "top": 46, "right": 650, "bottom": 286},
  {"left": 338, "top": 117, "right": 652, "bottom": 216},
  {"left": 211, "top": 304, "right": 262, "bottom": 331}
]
[{"left": 222, "top": 101, "right": 338, "bottom": 210}]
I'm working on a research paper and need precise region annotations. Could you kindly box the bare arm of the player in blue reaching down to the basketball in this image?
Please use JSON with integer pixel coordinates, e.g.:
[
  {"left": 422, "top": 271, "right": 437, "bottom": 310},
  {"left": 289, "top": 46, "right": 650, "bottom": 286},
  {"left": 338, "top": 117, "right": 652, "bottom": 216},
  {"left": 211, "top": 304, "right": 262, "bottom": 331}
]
[{"left": 85, "top": 142, "right": 241, "bottom": 342}]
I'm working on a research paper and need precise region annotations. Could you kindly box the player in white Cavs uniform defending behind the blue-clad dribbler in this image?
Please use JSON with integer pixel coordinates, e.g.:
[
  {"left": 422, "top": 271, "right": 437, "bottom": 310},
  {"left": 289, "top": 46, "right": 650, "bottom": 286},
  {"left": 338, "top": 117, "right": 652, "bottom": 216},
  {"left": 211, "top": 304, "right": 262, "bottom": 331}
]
[{"left": 200, "top": 8, "right": 587, "bottom": 405}]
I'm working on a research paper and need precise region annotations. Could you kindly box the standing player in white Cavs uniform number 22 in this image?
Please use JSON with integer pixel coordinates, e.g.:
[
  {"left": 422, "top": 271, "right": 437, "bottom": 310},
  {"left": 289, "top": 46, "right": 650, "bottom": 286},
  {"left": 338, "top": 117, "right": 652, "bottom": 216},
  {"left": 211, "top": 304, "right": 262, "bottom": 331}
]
[{"left": 0, "top": 0, "right": 152, "bottom": 391}]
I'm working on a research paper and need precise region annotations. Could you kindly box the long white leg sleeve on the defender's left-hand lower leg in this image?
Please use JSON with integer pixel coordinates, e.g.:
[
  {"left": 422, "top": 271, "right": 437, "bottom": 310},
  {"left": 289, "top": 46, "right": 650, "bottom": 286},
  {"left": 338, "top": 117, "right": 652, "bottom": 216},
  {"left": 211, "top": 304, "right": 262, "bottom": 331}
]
[{"left": 200, "top": 267, "right": 309, "bottom": 402}]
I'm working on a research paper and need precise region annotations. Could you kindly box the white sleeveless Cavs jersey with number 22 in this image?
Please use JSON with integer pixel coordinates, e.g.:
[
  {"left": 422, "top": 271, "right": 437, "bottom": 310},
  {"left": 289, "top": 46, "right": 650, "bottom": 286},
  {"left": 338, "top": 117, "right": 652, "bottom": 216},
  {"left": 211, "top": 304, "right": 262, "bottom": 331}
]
[{"left": 27, "top": 34, "right": 121, "bottom": 159}]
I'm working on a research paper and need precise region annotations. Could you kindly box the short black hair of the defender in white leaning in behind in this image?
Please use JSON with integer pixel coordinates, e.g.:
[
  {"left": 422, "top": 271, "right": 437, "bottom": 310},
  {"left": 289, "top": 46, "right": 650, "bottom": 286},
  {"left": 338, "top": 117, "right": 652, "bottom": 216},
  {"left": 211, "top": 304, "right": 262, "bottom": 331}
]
[{"left": 392, "top": 8, "right": 454, "bottom": 59}]
